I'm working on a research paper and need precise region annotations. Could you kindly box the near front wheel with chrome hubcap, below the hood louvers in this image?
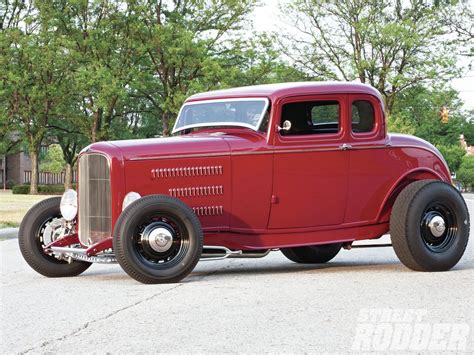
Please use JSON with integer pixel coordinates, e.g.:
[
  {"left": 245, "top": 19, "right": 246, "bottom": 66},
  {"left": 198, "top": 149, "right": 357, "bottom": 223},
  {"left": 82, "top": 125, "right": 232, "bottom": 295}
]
[{"left": 113, "top": 195, "right": 203, "bottom": 284}]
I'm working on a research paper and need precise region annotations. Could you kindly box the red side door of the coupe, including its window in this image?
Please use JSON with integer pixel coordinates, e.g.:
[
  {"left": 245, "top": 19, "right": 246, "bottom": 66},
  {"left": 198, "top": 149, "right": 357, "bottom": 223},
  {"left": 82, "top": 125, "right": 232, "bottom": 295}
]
[{"left": 269, "top": 95, "right": 349, "bottom": 229}]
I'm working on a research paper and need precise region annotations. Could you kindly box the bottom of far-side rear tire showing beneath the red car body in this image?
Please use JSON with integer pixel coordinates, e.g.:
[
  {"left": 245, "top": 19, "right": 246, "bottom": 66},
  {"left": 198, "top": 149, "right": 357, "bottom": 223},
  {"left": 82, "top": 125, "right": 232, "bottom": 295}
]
[{"left": 280, "top": 243, "right": 342, "bottom": 264}]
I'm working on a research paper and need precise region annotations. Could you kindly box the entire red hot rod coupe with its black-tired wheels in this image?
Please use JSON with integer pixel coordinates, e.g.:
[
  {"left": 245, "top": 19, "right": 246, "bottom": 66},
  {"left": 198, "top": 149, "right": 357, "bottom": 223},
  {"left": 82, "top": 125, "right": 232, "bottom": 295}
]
[{"left": 19, "top": 83, "right": 469, "bottom": 283}]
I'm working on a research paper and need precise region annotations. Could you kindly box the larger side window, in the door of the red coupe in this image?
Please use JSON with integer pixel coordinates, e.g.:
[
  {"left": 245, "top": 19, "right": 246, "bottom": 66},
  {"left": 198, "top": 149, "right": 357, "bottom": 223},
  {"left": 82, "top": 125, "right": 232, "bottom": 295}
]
[{"left": 281, "top": 101, "right": 340, "bottom": 135}]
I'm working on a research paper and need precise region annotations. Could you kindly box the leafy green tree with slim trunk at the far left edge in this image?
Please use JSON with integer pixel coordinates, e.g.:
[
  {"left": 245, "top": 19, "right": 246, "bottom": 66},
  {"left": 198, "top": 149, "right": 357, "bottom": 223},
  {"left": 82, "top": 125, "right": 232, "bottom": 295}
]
[{"left": 0, "top": 1, "right": 71, "bottom": 194}]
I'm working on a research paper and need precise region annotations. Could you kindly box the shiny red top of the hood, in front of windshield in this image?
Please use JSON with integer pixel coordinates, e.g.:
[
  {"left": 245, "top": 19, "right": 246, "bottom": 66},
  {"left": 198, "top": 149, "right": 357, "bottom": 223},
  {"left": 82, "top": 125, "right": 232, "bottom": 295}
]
[{"left": 105, "top": 134, "right": 230, "bottom": 160}]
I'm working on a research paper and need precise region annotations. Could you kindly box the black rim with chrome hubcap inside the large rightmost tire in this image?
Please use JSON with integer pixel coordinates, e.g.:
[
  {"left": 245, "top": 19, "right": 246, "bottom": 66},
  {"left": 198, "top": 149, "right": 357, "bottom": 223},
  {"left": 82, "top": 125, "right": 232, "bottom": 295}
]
[{"left": 420, "top": 203, "right": 458, "bottom": 253}]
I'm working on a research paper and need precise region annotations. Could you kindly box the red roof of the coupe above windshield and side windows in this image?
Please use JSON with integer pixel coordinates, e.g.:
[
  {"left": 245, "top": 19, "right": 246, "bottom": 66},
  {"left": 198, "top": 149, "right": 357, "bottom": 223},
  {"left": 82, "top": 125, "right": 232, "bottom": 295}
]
[{"left": 186, "top": 81, "right": 382, "bottom": 102}]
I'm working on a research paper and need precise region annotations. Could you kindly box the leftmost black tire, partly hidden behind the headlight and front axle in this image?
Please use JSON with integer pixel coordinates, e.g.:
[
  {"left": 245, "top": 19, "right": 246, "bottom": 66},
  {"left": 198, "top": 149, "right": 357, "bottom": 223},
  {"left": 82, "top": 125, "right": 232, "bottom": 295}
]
[{"left": 18, "top": 197, "right": 91, "bottom": 277}]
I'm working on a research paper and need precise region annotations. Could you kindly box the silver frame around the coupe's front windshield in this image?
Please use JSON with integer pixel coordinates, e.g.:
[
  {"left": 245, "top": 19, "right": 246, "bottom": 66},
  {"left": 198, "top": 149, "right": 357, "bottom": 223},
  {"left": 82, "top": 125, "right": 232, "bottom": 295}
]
[{"left": 172, "top": 97, "right": 270, "bottom": 134}]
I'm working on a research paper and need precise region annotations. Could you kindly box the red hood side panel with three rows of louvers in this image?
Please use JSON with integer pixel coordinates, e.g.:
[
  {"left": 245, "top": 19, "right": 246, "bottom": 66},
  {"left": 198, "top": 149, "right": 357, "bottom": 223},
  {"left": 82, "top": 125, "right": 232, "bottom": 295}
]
[{"left": 124, "top": 156, "right": 232, "bottom": 229}]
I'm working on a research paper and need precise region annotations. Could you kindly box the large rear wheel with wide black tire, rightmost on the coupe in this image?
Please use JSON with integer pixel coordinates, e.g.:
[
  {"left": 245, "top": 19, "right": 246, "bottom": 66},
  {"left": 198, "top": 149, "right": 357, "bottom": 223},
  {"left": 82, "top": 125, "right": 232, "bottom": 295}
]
[{"left": 390, "top": 180, "right": 469, "bottom": 271}]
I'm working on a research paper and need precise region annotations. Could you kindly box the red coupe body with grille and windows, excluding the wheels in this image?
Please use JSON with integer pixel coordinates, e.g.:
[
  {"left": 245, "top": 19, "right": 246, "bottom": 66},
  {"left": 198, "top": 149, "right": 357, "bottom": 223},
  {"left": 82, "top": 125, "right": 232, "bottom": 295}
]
[{"left": 19, "top": 82, "right": 470, "bottom": 284}]
